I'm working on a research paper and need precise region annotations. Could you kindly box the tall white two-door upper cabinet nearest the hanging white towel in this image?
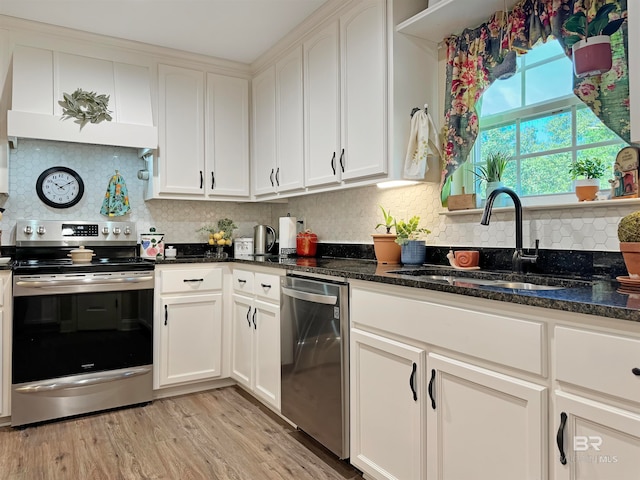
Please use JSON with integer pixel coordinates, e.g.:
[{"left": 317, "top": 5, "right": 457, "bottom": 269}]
[{"left": 304, "top": 0, "right": 387, "bottom": 187}]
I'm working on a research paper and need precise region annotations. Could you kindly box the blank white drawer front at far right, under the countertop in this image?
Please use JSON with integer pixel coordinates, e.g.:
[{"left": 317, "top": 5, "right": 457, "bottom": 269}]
[{"left": 555, "top": 326, "right": 640, "bottom": 402}]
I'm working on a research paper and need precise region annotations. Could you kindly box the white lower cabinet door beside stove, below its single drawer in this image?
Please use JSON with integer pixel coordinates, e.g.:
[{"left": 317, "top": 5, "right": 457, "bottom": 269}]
[{"left": 155, "top": 293, "right": 222, "bottom": 386}]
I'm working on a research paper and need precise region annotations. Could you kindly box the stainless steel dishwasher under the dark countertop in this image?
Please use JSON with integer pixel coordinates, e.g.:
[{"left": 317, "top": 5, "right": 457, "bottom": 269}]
[{"left": 280, "top": 273, "right": 349, "bottom": 459}]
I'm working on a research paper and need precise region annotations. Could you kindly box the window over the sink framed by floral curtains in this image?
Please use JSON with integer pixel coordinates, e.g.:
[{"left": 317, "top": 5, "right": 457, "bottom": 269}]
[{"left": 460, "top": 40, "right": 626, "bottom": 203}]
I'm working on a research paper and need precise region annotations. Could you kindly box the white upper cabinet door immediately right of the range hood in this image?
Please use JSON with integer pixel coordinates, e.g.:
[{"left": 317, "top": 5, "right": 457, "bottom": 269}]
[{"left": 158, "top": 65, "right": 204, "bottom": 196}]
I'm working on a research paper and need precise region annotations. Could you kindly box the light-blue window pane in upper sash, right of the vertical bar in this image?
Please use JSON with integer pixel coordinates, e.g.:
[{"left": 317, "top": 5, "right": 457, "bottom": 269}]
[{"left": 525, "top": 57, "right": 573, "bottom": 105}]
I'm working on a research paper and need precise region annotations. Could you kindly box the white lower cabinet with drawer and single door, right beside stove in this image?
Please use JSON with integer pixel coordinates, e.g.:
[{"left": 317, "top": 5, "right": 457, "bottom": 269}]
[{"left": 154, "top": 266, "right": 223, "bottom": 389}]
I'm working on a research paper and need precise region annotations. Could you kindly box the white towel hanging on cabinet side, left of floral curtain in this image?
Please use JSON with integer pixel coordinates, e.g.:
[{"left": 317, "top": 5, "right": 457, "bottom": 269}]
[{"left": 404, "top": 108, "right": 441, "bottom": 180}]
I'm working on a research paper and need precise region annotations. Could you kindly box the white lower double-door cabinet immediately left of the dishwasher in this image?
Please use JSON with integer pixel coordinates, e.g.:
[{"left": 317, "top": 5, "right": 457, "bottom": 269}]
[{"left": 231, "top": 269, "right": 280, "bottom": 410}]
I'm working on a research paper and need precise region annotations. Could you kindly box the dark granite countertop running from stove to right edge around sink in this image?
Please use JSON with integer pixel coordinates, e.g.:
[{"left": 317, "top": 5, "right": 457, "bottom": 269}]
[{"left": 158, "top": 256, "right": 640, "bottom": 322}]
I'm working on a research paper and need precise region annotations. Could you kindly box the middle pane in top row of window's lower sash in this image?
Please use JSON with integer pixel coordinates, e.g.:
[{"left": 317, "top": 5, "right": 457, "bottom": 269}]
[{"left": 520, "top": 112, "right": 571, "bottom": 155}]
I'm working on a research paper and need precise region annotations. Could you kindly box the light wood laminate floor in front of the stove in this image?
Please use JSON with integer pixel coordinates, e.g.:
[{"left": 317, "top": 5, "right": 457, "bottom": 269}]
[{"left": 0, "top": 387, "right": 362, "bottom": 480}]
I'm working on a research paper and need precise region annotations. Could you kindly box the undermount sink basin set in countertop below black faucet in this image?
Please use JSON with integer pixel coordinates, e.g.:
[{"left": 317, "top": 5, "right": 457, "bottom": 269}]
[{"left": 387, "top": 268, "right": 567, "bottom": 290}]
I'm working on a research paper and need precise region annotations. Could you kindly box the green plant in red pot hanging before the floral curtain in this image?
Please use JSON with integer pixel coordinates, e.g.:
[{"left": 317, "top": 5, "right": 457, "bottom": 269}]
[{"left": 564, "top": 0, "right": 626, "bottom": 78}]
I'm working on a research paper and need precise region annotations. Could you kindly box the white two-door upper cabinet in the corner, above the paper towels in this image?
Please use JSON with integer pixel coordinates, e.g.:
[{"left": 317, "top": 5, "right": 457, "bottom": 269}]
[{"left": 252, "top": 48, "right": 303, "bottom": 196}]
